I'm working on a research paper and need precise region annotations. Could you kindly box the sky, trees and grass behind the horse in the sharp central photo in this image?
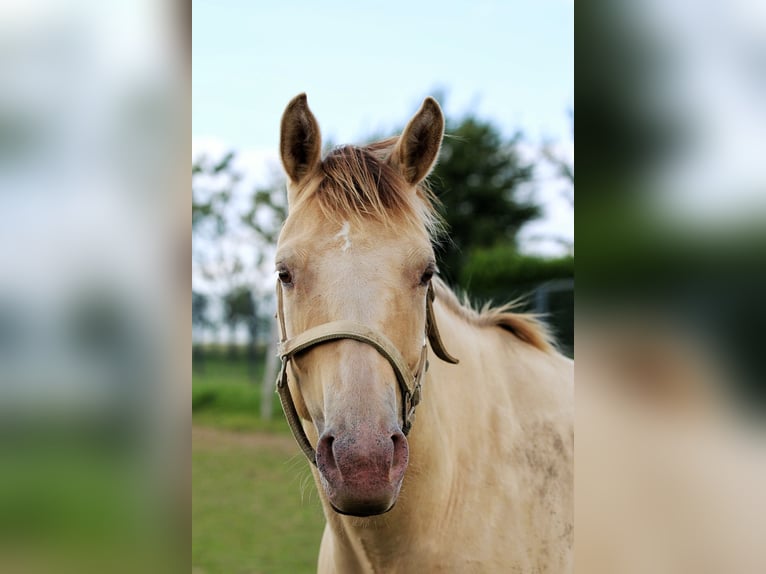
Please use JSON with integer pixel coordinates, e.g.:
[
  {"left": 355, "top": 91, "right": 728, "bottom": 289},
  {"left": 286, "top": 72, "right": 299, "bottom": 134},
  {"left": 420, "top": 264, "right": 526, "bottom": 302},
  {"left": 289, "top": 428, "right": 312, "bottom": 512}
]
[{"left": 192, "top": 0, "right": 574, "bottom": 573}]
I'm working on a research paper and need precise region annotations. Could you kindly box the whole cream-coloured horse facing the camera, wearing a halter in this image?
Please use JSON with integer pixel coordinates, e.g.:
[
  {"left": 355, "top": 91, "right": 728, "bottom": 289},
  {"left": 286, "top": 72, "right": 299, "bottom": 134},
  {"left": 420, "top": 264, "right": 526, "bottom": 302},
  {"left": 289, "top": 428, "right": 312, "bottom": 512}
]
[{"left": 276, "top": 94, "right": 574, "bottom": 573}]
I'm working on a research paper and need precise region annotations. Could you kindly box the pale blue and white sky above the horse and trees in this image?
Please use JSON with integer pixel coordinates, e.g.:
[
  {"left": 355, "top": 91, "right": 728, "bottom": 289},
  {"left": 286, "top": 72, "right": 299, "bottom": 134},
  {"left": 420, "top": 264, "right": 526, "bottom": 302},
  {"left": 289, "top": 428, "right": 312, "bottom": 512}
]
[{"left": 192, "top": 0, "right": 574, "bottom": 254}]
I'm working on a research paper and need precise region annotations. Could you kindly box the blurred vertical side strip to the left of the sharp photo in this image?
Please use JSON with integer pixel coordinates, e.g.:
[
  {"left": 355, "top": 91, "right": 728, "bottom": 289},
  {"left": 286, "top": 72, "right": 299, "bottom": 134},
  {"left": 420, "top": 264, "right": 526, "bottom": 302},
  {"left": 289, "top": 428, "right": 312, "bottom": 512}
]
[{"left": 0, "top": 0, "right": 191, "bottom": 574}]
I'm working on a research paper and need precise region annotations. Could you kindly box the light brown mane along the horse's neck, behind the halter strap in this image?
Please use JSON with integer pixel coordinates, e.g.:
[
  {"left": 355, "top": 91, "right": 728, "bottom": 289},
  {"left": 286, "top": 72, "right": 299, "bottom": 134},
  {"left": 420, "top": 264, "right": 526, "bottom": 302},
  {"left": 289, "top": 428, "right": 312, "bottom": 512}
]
[{"left": 433, "top": 278, "right": 555, "bottom": 353}]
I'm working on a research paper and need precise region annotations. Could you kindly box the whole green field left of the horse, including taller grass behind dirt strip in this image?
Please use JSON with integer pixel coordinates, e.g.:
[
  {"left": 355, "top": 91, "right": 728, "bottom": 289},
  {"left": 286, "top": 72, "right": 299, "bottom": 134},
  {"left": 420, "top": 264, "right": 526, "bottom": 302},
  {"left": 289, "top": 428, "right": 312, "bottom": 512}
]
[{"left": 192, "top": 358, "right": 324, "bottom": 574}]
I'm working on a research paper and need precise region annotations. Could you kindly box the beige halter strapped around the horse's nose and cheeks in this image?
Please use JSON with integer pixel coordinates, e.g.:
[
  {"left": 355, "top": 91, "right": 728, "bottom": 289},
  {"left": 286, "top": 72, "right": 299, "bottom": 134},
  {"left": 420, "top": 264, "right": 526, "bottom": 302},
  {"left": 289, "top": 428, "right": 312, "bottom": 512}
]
[{"left": 277, "top": 281, "right": 458, "bottom": 466}]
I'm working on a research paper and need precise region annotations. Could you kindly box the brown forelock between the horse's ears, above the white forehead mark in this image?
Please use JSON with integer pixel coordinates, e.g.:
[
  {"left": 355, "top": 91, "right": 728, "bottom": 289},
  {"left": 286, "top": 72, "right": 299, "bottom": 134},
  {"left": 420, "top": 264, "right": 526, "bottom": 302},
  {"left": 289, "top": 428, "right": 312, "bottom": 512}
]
[{"left": 296, "top": 138, "right": 443, "bottom": 239}]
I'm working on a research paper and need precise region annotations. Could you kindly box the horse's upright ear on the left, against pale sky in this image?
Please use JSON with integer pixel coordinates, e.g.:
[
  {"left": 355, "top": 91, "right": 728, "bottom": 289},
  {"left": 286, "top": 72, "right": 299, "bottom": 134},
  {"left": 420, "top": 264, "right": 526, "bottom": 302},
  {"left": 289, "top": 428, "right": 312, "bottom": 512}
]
[{"left": 279, "top": 94, "right": 322, "bottom": 190}]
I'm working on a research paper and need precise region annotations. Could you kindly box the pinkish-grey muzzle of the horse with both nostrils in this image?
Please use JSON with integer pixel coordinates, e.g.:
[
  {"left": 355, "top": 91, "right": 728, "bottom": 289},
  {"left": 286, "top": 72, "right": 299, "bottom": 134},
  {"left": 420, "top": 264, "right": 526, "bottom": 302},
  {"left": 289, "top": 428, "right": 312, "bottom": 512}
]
[{"left": 316, "top": 426, "right": 409, "bottom": 516}]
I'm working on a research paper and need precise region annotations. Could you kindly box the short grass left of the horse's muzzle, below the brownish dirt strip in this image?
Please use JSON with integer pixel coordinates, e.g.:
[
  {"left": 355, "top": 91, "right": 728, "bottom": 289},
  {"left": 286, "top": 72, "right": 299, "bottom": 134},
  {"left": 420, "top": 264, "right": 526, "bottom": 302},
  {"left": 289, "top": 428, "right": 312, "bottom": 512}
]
[{"left": 192, "top": 426, "right": 324, "bottom": 574}]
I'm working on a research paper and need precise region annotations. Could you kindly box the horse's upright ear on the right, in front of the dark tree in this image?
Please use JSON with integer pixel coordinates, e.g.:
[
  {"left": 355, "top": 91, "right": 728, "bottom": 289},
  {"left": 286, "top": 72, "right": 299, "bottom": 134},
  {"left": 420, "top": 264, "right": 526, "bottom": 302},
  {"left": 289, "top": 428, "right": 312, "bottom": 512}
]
[{"left": 390, "top": 97, "right": 444, "bottom": 185}]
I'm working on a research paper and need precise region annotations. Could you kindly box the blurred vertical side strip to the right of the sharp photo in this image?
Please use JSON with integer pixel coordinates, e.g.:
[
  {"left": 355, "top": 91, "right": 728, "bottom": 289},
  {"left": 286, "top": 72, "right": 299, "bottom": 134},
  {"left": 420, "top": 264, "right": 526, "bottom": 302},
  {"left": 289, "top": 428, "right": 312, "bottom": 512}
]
[{"left": 575, "top": 0, "right": 766, "bottom": 573}]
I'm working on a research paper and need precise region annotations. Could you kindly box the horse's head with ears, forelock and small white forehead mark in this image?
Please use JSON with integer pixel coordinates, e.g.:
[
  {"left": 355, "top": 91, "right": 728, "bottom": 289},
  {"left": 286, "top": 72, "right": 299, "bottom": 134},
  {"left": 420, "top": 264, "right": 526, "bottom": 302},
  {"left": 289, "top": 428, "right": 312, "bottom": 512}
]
[{"left": 276, "top": 94, "right": 444, "bottom": 516}]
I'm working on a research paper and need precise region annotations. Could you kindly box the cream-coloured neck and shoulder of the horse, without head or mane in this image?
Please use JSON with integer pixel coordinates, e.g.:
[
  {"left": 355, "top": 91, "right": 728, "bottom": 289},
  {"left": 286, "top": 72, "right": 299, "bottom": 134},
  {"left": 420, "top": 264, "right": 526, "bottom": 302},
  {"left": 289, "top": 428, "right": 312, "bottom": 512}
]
[{"left": 314, "top": 287, "right": 574, "bottom": 574}]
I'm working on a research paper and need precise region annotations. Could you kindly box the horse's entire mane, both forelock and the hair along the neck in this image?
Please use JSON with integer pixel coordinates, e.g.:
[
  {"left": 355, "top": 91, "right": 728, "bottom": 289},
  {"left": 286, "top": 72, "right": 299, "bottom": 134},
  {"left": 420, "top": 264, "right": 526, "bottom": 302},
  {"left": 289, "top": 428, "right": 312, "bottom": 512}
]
[{"left": 298, "top": 137, "right": 554, "bottom": 353}]
